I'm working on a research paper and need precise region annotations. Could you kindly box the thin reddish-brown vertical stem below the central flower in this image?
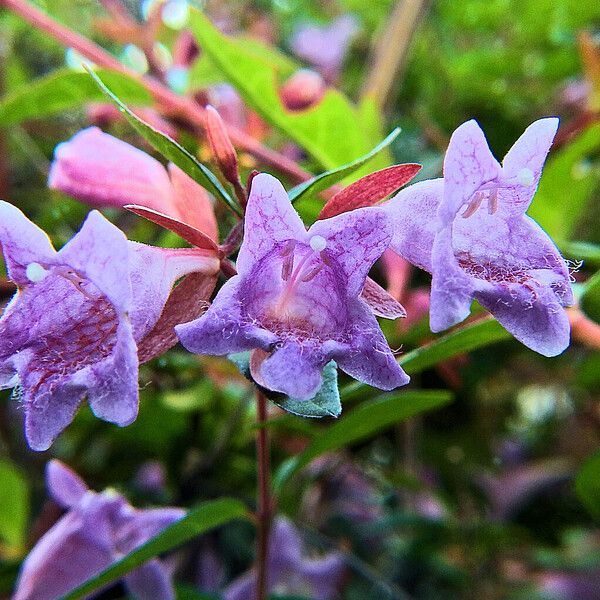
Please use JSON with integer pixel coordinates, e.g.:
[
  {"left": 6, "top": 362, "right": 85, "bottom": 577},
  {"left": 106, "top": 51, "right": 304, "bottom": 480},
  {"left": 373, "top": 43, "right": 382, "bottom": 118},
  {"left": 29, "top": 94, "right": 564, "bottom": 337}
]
[{"left": 255, "top": 391, "right": 273, "bottom": 600}]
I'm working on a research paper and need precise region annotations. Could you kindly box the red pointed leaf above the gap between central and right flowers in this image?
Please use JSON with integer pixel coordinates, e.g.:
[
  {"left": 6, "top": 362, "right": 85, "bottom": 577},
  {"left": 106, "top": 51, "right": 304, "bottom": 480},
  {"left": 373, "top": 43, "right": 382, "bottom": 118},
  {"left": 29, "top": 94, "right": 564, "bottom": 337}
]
[{"left": 319, "top": 164, "right": 421, "bottom": 219}]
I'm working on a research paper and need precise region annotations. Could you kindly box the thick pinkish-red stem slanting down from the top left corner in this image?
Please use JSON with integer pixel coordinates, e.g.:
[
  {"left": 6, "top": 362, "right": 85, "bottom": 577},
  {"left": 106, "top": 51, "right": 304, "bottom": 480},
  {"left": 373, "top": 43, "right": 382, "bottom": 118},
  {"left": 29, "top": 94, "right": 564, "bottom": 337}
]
[{"left": 0, "top": 0, "right": 312, "bottom": 182}]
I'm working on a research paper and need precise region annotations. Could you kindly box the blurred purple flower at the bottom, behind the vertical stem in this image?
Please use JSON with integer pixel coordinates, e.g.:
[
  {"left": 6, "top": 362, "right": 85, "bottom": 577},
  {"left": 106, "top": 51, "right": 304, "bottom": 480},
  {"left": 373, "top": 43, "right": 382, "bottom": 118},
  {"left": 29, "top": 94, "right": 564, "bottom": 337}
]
[{"left": 223, "top": 517, "right": 344, "bottom": 600}]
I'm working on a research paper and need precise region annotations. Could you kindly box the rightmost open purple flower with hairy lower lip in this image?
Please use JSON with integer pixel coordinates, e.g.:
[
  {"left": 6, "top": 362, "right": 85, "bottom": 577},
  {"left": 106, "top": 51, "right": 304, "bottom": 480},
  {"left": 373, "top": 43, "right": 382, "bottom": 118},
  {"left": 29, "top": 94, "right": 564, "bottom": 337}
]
[{"left": 386, "top": 118, "right": 573, "bottom": 356}]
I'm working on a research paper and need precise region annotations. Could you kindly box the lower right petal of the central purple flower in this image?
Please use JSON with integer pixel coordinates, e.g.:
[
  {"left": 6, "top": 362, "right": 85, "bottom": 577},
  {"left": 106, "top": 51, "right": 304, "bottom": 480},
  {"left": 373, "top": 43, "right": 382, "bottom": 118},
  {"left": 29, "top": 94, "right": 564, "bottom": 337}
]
[{"left": 332, "top": 300, "right": 410, "bottom": 390}]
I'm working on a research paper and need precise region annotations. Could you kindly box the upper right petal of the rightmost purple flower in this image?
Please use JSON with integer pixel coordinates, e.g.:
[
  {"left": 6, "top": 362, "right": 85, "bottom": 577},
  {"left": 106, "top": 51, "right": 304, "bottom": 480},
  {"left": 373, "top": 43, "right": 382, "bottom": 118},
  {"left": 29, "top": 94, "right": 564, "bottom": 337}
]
[{"left": 498, "top": 117, "right": 558, "bottom": 215}]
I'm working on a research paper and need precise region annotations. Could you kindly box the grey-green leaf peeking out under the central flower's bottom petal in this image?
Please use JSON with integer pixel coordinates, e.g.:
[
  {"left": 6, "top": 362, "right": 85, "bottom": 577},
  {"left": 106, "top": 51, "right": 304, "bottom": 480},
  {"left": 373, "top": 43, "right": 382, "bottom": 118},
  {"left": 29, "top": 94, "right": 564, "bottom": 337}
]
[{"left": 227, "top": 352, "right": 342, "bottom": 418}]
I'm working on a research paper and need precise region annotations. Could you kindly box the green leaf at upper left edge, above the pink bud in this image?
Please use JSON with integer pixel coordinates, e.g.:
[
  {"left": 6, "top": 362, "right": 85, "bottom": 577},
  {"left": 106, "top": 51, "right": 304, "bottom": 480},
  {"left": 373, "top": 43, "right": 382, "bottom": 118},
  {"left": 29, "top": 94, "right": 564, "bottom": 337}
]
[{"left": 0, "top": 69, "right": 152, "bottom": 125}]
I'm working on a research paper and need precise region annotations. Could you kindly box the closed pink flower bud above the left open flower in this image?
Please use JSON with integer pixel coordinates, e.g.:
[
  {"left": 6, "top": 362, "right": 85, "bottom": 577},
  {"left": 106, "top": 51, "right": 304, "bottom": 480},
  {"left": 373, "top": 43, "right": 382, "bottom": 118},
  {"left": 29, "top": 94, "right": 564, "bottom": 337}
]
[{"left": 48, "top": 127, "right": 176, "bottom": 216}]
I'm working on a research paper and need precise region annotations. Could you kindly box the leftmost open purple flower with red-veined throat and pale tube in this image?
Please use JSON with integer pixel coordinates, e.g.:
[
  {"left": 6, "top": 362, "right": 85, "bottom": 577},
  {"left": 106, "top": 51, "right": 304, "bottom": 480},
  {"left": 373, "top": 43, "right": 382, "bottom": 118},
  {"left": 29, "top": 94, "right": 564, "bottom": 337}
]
[{"left": 0, "top": 202, "right": 218, "bottom": 450}]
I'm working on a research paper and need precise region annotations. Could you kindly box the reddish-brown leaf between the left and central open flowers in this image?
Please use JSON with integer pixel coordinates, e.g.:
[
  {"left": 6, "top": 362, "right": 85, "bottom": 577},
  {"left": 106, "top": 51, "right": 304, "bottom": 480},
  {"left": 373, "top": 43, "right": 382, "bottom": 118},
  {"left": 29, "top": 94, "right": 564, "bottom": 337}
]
[{"left": 138, "top": 273, "right": 217, "bottom": 363}]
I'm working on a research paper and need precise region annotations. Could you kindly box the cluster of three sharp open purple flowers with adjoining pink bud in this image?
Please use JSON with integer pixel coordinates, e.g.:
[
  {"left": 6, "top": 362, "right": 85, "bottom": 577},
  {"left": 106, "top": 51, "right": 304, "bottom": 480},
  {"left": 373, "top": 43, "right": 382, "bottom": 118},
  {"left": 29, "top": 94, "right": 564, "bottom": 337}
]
[{"left": 0, "top": 118, "right": 573, "bottom": 450}]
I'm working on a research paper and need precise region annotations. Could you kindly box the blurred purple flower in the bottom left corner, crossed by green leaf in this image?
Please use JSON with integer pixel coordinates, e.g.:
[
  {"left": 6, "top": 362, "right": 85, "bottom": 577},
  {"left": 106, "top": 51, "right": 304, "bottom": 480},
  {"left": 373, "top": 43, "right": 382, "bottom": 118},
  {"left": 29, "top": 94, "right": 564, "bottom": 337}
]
[{"left": 13, "top": 460, "right": 185, "bottom": 600}]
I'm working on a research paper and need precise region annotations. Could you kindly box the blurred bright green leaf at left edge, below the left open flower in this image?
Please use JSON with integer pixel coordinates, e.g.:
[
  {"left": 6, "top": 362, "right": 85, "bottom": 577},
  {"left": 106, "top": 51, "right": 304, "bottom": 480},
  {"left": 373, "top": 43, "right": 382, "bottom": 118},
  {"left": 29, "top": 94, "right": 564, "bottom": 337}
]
[{"left": 0, "top": 460, "right": 29, "bottom": 548}]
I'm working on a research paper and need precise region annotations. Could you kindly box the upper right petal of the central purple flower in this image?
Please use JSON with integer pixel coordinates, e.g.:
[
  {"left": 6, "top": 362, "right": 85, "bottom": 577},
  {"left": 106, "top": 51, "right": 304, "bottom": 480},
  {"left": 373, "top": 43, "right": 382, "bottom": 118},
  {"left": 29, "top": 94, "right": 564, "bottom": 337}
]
[{"left": 308, "top": 208, "right": 392, "bottom": 297}]
